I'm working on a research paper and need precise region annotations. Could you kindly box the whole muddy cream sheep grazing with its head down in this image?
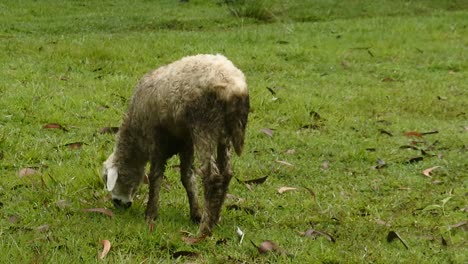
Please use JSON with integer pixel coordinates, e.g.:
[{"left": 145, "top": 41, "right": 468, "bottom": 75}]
[{"left": 102, "top": 54, "right": 250, "bottom": 236}]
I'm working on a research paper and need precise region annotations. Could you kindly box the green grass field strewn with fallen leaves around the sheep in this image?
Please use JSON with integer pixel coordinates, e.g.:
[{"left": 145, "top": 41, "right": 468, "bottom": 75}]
[{"left": 0, "top": 0, "right": 468, "bottom": 263}]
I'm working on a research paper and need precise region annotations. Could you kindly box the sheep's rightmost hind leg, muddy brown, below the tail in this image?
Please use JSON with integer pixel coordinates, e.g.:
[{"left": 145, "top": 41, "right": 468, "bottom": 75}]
[{"left": 199, "top": 144, "right": 232, "bottom": 235}]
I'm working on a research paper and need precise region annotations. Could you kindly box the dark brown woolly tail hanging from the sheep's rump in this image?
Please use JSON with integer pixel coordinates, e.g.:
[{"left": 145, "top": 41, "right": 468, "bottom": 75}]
[{"left": 226, "top": 94, "right": 250, "bottom": 156}]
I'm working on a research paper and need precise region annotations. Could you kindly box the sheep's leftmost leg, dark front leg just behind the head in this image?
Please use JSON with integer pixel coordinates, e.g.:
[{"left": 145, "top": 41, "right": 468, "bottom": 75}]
[{"left": 145, "top": 159, "right": 166, "bottom": 222}]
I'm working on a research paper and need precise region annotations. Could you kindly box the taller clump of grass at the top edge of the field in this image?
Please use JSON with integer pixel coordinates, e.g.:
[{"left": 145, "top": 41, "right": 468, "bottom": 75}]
[{"left": 224, "top": 0, "right": 276, "bottom": 22}]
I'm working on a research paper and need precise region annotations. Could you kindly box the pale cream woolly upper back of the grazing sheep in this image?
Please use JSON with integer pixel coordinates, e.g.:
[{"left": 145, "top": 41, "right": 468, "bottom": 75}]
[{"left": 126, "top": 55, "right": 248, "bottom": 134}]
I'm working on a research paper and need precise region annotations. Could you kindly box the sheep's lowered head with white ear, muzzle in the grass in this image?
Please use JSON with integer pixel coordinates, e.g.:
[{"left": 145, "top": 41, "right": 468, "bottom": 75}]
[{"left": 102, "top": 153, "right": 143, "bottom": 209}]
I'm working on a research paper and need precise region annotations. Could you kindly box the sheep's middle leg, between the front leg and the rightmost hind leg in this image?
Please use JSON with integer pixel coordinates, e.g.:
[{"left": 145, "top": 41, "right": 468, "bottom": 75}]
[{"left": 180, "top": 146, "right": 201, "bottom": 223}]
